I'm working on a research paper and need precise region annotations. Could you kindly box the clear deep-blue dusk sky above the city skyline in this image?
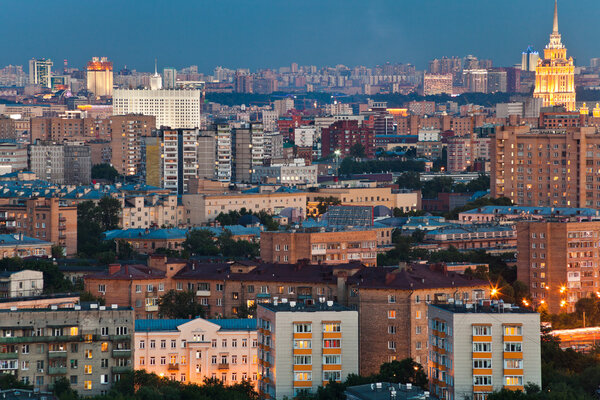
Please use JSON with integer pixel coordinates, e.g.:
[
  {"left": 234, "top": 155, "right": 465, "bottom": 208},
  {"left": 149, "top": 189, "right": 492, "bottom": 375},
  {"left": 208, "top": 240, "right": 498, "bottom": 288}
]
[{"left": 0, "top": 0, "right": 600, "bottom": 73}]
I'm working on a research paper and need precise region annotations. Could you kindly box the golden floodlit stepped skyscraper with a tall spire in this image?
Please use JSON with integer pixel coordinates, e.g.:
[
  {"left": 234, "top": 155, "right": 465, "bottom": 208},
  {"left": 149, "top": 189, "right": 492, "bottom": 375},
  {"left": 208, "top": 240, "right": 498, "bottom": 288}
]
[{"left": 533, "top": 0, "right": 575, "bottom": 111}]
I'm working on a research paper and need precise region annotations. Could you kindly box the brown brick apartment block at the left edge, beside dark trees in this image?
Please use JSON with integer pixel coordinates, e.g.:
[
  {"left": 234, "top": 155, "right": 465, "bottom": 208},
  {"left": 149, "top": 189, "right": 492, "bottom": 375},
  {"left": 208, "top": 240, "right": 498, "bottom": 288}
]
[{"left": 0, "top": 197, "right": 77, "bottom": 256}]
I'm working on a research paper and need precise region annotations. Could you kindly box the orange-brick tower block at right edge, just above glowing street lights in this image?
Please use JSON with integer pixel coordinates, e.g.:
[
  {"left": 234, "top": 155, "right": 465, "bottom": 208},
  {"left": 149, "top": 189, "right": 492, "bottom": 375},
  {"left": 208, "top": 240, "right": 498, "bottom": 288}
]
[{"left": 517, "top": 218, "right": 600, "bottom": 314}]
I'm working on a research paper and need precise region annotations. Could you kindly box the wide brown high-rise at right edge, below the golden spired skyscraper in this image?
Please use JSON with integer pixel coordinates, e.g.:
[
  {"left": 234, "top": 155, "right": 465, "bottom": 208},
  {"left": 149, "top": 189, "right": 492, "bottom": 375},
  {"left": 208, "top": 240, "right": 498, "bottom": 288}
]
[{"left": 490, "top": 126, "right": 600, "bottom": 207}]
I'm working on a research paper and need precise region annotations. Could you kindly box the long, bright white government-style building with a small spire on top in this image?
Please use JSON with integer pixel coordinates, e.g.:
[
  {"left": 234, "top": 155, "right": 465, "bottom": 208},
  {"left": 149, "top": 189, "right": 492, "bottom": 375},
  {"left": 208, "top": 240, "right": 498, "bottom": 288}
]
[{"left": 113, "top": 89, "right": 201, "bottom": 129}]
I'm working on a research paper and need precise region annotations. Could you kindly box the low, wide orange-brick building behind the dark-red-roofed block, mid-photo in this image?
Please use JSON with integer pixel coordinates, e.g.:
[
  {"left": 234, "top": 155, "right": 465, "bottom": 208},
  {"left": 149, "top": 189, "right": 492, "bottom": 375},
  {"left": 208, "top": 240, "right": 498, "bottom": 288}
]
[{"left": 260, "top": 228, "right": 382, "bottom": 266}]
